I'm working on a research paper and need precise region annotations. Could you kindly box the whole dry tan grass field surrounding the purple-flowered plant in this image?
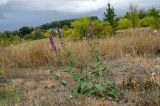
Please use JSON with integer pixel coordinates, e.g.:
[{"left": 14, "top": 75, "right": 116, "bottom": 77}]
[{"left": 0, "top": 28, "right": 160, "bottom": 106}]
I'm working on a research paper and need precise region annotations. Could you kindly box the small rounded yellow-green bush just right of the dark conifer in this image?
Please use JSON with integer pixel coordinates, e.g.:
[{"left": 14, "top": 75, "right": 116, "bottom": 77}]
[{"left": 118, "top": 18, "right": 132, "bottom": 29}]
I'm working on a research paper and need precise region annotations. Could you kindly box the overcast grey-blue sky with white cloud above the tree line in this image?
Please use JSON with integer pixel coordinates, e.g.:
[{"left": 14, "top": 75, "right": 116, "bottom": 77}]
[{"left": 0, "top": 0, "right": 160, "bottom": 31}]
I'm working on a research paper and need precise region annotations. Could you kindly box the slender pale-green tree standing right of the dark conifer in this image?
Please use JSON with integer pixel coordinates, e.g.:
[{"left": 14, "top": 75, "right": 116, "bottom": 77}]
[{"left": 127, "top": 4, "right": 139, "bottom": 28}]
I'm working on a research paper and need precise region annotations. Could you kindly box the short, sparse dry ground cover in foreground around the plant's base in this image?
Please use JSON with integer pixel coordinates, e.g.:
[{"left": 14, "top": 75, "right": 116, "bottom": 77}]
[{"left": 3, "top": 57, "right": 160, "bottom": 106}]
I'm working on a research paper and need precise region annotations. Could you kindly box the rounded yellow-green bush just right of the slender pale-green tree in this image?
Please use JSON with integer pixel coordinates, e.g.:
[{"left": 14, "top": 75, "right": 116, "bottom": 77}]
[{"left": 139, "top": 16, "right": 154, "bottom": 27}]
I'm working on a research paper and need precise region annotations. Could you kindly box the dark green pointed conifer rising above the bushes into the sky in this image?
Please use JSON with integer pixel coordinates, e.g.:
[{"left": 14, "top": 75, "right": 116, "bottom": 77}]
[{"left": 104, "top": 3, "right": 116, "bottom": 28}]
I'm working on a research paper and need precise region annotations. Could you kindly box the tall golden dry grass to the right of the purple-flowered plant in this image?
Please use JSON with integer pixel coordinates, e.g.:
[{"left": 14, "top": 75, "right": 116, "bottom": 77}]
[{"left": 100, "top": 28, "right": 160, "bottom": 56}]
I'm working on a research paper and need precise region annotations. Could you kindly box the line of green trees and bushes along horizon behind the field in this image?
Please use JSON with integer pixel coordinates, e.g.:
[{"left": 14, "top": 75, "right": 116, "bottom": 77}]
[{"left": 0, "top": 3, "right": 160, "bottom": 44}]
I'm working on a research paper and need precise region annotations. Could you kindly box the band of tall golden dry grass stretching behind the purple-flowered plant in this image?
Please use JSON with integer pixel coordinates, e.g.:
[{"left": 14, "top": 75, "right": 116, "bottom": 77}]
[{"left": 0, "top": 28, "right": 160, "bottom": 67}]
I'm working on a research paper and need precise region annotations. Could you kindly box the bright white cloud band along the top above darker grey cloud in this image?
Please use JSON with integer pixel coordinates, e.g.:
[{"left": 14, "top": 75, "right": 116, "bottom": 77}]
[{"left": 0, "top": 0, "right": 160, "bottom": 13}]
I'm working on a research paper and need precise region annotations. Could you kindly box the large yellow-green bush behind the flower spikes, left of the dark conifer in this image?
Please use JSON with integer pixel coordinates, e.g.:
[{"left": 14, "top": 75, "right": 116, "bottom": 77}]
[{"left": 62, "top": 17, "right": 113, "bottom": 40}]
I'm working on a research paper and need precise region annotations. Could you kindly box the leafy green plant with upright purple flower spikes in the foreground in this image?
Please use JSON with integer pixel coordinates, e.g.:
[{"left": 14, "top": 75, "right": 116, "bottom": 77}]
[{"left": 45, "top": 19, "right": 119, "bottom": 98}]
